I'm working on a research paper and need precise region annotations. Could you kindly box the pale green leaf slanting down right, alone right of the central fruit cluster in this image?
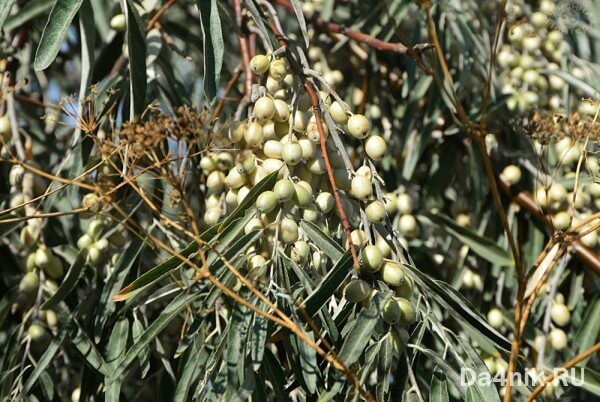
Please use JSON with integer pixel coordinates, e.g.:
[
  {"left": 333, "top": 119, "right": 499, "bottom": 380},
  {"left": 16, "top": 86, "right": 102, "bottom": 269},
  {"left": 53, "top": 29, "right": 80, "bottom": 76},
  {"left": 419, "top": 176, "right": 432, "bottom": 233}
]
[{"left": 427, "top": 214, "right": 515, "bottom": 267}]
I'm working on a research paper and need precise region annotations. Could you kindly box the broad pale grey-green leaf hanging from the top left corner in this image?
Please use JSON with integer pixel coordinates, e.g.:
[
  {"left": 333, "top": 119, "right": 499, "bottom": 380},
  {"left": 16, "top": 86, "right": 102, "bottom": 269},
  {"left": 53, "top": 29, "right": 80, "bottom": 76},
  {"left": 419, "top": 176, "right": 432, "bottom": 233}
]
[{"left": 33, "top": 0, "right": 83, "bottom": 71}]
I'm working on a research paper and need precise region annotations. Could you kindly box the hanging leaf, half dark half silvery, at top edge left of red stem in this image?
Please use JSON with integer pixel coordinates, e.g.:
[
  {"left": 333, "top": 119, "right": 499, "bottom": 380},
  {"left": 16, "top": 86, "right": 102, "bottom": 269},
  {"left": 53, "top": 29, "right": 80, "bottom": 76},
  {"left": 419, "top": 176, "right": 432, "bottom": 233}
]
[{"left": 197, "top": 0, "right": 225, "bottom": 101}]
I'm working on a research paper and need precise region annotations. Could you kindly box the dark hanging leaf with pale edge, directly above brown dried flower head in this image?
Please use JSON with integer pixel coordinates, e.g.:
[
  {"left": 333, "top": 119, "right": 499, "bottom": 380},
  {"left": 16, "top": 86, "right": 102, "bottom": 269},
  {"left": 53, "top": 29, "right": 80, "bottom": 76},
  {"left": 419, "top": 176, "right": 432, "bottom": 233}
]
[{"left": 126, "top": 0, "right": 146, "bottom": 119}]
